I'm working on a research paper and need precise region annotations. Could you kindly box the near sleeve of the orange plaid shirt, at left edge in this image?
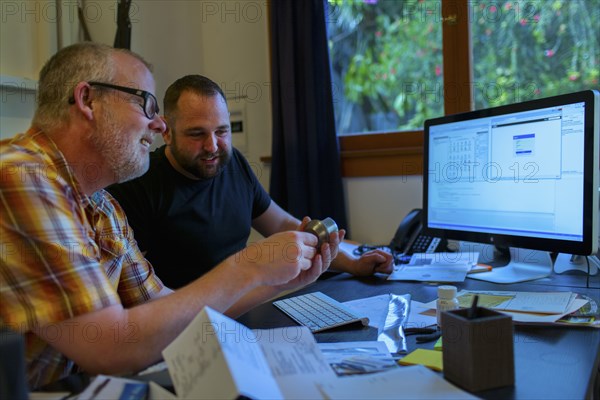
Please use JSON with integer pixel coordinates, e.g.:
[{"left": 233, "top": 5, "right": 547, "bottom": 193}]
[{"left": 0, "top": 157, "right": 120, "bottom": 332}]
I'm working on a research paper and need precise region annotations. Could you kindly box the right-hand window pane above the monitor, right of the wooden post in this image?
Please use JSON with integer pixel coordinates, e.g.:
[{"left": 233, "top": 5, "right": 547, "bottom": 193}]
[{"left": 469, "top": 0, "right": 600, "bottom": 109}]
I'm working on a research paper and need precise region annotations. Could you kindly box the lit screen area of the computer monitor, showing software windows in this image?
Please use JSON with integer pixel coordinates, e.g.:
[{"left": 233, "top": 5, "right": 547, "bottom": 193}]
[{"left": 427, "top": 102, "right": 585, "bottom": 241}]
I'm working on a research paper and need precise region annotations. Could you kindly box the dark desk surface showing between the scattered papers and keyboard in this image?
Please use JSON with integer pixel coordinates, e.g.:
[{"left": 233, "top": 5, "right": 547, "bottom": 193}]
[{"left": 238, "top": 274, "right": 600, "bottom": 399}]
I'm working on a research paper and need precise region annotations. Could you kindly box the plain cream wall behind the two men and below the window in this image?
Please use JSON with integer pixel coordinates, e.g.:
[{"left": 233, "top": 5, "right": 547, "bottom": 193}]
[{"left": 0, "top": 0, "right": 422, "bottom": 244}]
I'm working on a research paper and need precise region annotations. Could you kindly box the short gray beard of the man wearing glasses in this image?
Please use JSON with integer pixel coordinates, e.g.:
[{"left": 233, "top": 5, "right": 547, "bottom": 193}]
[{"left": 91, "top": 109, "right": 150, "bottom": 183}]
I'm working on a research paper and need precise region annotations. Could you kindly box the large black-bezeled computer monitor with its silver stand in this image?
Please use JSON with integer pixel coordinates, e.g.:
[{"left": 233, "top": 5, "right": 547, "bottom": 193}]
[{"left": 423, "top": 90, "right": 600, "bottom": 283}]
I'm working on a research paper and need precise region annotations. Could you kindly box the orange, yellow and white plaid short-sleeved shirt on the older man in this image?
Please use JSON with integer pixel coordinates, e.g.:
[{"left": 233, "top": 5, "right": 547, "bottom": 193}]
[{"left": 0, "top": 130, "right": 163, "bottom": 388}]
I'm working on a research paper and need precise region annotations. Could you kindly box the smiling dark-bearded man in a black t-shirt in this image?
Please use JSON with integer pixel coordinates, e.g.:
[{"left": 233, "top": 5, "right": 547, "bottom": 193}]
[{"left": 107, "top": 75, "right": 393, "bottom": 287}]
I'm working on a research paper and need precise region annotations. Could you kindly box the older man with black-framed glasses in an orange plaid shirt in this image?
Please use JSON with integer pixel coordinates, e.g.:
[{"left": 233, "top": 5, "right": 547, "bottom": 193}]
[{"left": 0, "top": 42, "right": 344, "bottom": 388}]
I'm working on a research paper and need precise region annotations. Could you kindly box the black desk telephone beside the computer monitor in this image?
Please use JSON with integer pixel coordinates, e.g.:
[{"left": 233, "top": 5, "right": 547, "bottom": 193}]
[{"left": 389, "top": 208, "right": 448, "bottom": 256}]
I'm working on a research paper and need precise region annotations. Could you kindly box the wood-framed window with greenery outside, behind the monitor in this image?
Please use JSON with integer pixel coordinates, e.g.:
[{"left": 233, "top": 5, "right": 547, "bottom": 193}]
[{"left": 327, "top": 0, "right": 600, "bottom": 176}]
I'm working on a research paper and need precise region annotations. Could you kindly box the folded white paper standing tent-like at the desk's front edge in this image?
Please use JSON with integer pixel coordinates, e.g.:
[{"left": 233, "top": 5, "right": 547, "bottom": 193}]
[{"left": 163, "top": 307, "right": 337, "bottom": 399}]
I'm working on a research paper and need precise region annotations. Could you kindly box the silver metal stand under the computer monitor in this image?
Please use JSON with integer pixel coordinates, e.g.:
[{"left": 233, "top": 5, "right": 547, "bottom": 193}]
[{"left": 460, "top": 242, "right": 552, "bottom": 283}]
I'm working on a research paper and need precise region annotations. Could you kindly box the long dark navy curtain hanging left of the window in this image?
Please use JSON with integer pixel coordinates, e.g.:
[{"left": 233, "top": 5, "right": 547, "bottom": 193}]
[{"left": 270, "top": 0, "right": 347, "bottom": 234}]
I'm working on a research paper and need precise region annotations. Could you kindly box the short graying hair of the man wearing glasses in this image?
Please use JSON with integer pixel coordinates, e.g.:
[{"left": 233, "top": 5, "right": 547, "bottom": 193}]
[{"left": 32, "top": 42, "right": 152, "bottom": 131}]
